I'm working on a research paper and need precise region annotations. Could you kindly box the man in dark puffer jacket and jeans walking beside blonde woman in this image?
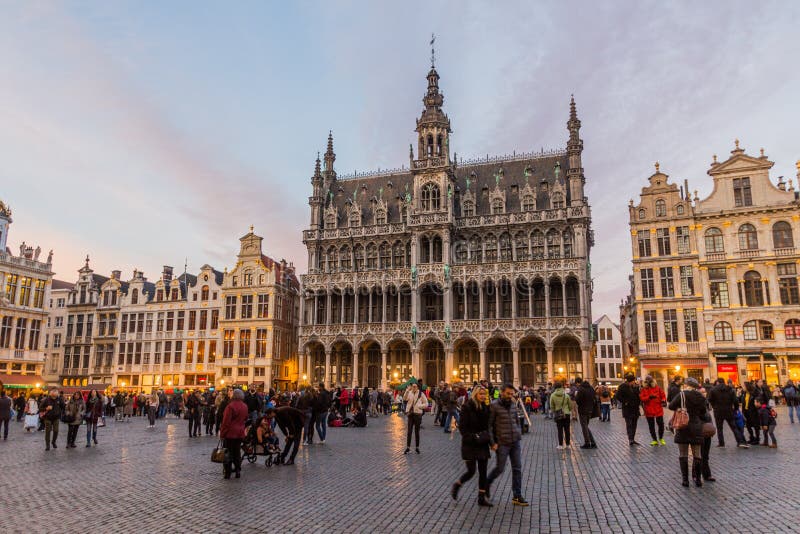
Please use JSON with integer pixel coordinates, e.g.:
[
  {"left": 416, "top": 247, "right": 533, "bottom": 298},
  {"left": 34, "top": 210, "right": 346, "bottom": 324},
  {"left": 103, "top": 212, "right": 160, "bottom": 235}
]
[{"left": 486, "top": 384, "right": 528, "bottom": 506}]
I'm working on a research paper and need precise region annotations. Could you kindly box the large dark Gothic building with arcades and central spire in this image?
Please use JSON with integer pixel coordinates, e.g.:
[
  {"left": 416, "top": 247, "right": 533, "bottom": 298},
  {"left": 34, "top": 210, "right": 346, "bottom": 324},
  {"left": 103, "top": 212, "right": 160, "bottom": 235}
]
[{"left": 299, "top": 66, "right": 593, "bottom": 387}]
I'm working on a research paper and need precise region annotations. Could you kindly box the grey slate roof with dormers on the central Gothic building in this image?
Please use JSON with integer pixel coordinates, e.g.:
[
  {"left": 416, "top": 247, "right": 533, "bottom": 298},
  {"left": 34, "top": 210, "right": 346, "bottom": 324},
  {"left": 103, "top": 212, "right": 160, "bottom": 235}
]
[{"left": 325, "top": 151, "right": 569, "bottom": 224}]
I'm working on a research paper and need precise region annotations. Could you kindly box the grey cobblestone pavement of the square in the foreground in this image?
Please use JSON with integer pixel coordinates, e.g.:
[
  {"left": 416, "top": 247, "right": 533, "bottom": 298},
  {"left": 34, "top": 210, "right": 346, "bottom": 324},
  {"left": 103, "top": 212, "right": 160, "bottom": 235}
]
[{"left": 0, "top": 408, "right": 800, "bottom": 533}]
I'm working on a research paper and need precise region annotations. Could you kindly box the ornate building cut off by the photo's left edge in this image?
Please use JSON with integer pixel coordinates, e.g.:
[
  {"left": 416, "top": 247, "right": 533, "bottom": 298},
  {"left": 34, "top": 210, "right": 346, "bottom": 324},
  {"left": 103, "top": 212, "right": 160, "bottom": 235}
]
[{"left": 0, "top": 201, "right": 53, "bottom": 388}]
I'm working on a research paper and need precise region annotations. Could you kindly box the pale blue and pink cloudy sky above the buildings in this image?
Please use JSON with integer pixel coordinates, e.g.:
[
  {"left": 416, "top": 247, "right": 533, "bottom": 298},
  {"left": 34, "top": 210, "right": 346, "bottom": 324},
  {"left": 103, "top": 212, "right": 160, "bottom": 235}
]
[{"left": 0, "top": 0, "right": 800, "bottom": 320}]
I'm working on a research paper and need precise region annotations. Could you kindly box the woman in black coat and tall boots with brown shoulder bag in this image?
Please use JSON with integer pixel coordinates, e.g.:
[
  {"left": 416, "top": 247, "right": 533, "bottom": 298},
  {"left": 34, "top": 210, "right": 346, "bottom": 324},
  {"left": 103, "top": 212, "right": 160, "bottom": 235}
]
[{"left": 669, "top": 377, "right": 706, "bottom": 487}]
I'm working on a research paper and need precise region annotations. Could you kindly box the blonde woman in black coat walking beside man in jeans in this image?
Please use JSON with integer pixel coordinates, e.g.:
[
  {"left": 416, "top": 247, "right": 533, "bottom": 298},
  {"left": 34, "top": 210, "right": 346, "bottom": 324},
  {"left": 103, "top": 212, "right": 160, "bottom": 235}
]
[{"left": 450, "top": 386, "right": 492, "bottom": 506}]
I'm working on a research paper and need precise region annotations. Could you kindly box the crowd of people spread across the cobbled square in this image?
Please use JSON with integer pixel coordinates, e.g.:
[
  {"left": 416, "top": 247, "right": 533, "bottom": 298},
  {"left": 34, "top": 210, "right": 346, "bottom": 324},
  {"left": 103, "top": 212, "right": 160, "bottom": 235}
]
[{"left": 0, "top": 374, "right": 800, "bottom": 506}]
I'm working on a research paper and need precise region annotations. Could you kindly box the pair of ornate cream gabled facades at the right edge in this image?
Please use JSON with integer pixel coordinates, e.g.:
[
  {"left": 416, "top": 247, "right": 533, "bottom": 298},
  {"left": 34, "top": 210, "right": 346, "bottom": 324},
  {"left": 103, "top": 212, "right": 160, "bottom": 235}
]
[{"left": 620, "top": 140, "right": 800, "bottom": 392}]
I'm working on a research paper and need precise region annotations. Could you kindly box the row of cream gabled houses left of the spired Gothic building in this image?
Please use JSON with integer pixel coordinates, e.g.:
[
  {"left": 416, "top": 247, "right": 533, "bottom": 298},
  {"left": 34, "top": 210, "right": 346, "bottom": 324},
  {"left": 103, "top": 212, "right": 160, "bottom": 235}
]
[{"left": 44, "top": 228, "right": 299, "bottom": 392}]
